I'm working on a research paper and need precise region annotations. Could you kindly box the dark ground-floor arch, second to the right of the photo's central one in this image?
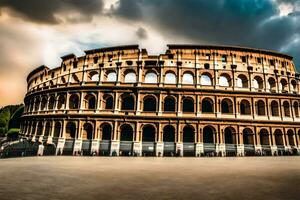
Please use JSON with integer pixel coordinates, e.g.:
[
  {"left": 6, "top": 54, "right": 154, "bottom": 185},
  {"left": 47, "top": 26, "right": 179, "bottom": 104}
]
[{"left": 182, "top": 125, "right": 195, "bottom": 156}]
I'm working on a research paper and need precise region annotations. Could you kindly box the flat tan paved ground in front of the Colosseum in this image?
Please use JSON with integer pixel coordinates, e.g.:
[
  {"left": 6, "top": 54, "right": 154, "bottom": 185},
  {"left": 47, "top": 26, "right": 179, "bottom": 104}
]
[{"left": 0, "top": 157, "right": 300, "bottom": 200}]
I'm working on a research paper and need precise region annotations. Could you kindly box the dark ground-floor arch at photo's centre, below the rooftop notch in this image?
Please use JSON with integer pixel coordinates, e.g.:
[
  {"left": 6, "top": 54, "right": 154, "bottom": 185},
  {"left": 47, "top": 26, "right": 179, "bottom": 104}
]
[{"left": 142, "top": 124, "right": 156, "bottom": 156}]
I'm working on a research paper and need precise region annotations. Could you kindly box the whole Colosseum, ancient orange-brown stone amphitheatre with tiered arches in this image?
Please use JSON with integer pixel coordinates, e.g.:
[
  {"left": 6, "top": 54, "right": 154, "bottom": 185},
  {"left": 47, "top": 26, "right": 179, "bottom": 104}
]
[{"left": 21, "top": 45, "right": 300, "bottom": 156}]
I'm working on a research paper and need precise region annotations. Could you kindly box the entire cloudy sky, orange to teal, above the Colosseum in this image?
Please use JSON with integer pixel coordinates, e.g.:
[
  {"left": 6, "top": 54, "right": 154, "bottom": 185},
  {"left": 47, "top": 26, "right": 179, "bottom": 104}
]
[{"left": 0, "top": 0, "right": 300, "bottom": 107}]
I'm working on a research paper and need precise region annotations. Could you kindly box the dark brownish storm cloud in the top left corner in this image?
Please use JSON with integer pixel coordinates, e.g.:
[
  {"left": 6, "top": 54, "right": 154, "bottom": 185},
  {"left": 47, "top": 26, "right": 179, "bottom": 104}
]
[{"left": 0, "top": 0, "right": 103, "bottom": 24}]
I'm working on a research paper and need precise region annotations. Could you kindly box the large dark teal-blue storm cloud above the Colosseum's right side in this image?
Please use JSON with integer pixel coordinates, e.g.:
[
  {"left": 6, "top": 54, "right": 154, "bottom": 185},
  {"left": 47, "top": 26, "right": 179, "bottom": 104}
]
[{"left": 112, "top": 0, "right": 300, "bottom": 67}]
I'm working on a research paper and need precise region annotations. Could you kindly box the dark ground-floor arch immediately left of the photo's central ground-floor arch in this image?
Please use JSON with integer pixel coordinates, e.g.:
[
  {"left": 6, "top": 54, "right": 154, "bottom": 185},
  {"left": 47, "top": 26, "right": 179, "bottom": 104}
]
[{"left": 120, "top": 124, "right": 134, "bottom": 156}]
